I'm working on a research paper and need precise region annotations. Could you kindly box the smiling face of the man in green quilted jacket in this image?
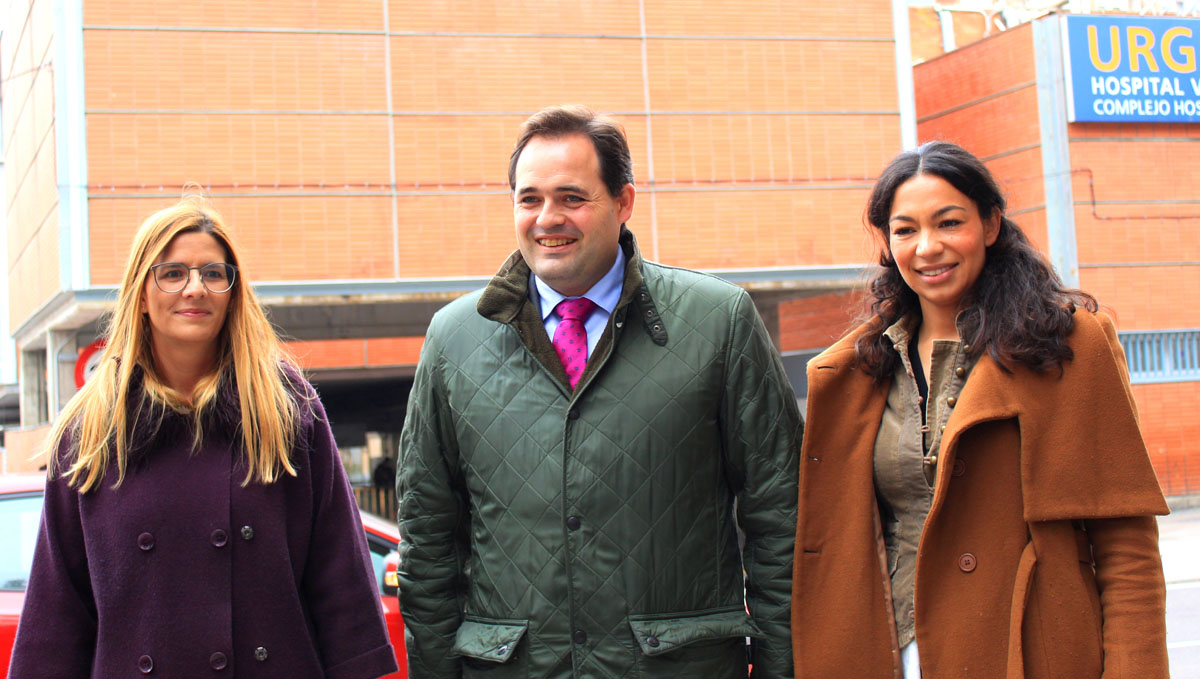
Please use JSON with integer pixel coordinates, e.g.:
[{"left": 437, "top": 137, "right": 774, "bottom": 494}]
[{"left": 512, "top": 134, "right": 634, "bottom": 296}]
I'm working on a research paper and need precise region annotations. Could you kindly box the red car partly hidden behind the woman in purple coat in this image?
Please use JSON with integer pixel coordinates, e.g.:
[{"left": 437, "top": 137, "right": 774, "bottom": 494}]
[{"left": 0, "top": 474, "right": 408, "bottom": 679}]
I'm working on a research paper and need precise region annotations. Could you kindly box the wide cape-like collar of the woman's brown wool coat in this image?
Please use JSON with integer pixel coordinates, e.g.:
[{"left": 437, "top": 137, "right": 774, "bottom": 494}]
[{"left": 804, "top": 312, "right": 1165, "bottom": 521}]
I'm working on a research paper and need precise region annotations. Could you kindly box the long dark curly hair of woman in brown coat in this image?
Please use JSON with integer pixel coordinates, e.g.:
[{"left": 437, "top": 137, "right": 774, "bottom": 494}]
[{"left": 854, "top": 142, "right": 1097, "bottom": 381}]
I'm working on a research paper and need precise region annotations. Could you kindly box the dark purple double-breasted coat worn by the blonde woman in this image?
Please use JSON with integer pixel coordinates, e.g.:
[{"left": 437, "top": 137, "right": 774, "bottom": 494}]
[{"left": 8, "top": 378, "right": 396, "bottom": 679}]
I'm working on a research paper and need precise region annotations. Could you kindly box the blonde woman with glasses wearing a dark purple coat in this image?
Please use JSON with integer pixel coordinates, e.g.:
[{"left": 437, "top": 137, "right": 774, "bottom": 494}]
[{"left": 10, "top": 198, "right": 396, "bottom": 679}]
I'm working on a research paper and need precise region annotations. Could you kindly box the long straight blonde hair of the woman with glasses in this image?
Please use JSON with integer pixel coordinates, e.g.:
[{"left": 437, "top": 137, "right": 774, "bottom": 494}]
[{"left": 47, "top": 196, "right": 305, "bottom": 493}]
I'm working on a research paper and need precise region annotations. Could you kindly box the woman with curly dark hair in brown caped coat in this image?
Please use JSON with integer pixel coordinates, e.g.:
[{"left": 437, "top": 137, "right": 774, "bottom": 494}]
[{"left": 792, "top": 142, "right": 1168, "bottom": 679}]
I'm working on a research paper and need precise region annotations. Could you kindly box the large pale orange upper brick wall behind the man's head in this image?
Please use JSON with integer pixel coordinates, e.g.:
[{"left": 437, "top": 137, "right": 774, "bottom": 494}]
[{"left": 75, "top": 0, "right": 900, "bottom": 292}]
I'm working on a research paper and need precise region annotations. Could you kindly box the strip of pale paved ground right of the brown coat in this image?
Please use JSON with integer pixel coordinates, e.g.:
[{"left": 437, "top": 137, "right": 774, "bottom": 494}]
[{"left": 1158, "top": 507, "right": 1200, "bottom": 679}]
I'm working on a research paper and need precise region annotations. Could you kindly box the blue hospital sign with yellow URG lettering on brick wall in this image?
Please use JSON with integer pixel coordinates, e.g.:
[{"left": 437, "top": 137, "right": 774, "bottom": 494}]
[{"left": 1063, "top": 14, "right": 1200, "bottom": 122}]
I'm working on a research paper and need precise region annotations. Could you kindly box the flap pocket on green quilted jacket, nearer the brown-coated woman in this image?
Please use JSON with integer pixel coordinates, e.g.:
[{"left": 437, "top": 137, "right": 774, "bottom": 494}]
[{"left": 629, "top": 606, "right": 762, "bottom": 662}]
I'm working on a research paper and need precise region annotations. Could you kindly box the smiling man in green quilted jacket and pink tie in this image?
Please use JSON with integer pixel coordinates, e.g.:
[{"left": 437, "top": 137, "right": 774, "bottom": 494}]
[{"left": 397, "top": 107, "right": 802, "bottom": 679}]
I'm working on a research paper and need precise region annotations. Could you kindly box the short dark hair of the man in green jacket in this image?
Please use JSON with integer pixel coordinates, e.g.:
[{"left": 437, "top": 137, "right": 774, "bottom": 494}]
[{"left": 509, "top": 106, "right": 634, "bottom": 198}]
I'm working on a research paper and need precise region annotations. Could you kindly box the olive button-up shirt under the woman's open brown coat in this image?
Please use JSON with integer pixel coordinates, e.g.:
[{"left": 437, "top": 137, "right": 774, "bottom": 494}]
[{"left": 875, "top": 317, "right": 974, "bottom": 648}]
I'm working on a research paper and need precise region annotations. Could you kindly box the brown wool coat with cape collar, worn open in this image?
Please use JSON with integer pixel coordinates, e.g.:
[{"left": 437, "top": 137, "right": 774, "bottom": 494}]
[{"left": 792, "top": 311, "right": 1168, "bottom": 679}]
